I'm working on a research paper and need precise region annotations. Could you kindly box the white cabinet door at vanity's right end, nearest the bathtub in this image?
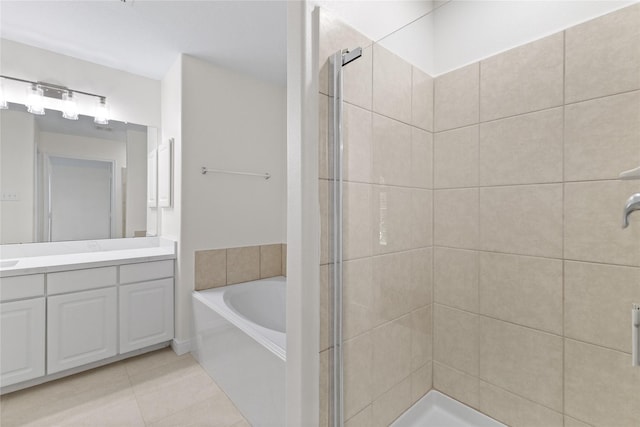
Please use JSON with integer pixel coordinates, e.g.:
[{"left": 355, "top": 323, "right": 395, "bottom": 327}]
[{"left": 120, "top": 278, "right": 173, "bottom": 353}]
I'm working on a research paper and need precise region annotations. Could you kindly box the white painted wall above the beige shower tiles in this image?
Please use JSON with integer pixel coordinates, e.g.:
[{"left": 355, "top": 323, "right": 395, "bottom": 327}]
[{"left": 312, "top": 0, "right": 637, "bottom": 76}]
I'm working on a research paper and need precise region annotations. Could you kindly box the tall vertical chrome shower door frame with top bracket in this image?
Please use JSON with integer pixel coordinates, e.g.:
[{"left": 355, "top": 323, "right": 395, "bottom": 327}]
[{"left": 329, "top": 47, "right": 362, "bottom": 427}]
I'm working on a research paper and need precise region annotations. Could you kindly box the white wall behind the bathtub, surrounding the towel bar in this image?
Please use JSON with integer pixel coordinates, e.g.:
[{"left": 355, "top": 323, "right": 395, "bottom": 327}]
[{"left": 165, "top": 56, "right": 286, "bottom": 348}]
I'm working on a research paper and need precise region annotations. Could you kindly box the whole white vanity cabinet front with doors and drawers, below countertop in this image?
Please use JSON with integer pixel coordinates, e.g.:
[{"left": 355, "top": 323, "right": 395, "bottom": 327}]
[{"left": 0, "top": 254, "right": 174, "bottom": 392}]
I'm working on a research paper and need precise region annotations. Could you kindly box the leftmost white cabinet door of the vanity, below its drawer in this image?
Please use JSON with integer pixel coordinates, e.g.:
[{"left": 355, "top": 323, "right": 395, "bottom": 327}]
[{"left": 0, "top": 298, "right": 45, "bottom": 387}]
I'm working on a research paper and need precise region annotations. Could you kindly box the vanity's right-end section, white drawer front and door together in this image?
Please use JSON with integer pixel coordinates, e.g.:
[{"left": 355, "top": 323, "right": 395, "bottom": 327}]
[{"left": 119, "top": 260, "right": 173, "bottom": 353}]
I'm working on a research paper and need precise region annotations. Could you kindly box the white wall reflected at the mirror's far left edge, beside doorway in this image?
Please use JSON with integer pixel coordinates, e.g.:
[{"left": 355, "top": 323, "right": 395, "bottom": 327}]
[{"left": 0, "top": 110, "right": 35, "bottom": 244}]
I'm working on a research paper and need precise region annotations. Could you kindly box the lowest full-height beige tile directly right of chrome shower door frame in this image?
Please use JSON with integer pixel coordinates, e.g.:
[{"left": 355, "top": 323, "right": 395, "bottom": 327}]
[{"left": 344, "top": 333, "right": 375, "bottom": 419}]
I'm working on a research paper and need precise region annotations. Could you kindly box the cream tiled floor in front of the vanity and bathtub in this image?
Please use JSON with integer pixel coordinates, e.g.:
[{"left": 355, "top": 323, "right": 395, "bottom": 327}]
[{"left": 0, "top": 348, "right": 249, "bottom": 427}]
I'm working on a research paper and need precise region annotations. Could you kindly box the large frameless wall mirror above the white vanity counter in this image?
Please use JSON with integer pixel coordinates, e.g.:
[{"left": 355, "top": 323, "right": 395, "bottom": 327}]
[{"left": 0, "top": 104, "right": 157, "bottom": 244}]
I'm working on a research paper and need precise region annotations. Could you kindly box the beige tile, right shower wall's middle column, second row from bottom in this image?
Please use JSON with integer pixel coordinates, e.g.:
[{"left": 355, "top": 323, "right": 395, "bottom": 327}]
[{"left": 480, "top": 317, "right": 563, "bottom": 411}]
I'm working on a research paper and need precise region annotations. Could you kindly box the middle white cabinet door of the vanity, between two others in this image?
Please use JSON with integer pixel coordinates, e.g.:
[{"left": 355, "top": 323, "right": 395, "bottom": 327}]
[{"left": 47, "top": 287, "right": 118, "bottom": 374}]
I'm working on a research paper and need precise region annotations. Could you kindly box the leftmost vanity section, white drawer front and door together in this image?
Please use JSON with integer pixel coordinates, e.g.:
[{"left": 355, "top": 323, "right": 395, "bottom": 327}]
[{"left": 0, "top": 274, "right": 45, "bottom": 387}]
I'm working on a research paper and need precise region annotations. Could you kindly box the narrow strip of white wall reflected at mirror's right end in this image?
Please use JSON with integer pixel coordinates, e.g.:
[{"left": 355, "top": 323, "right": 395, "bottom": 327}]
[{"left": 125, "top": 130, "right": 147, "bottom": 237}]
